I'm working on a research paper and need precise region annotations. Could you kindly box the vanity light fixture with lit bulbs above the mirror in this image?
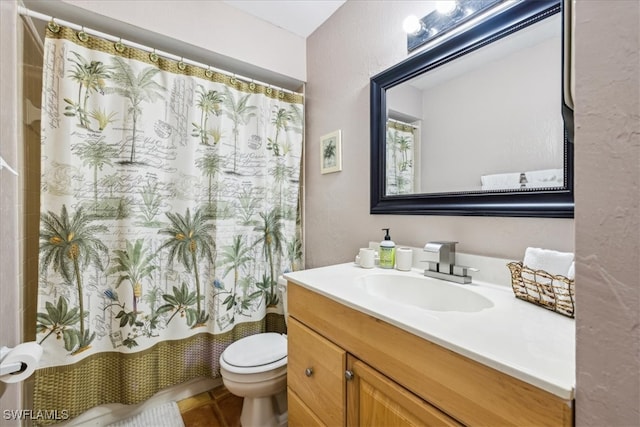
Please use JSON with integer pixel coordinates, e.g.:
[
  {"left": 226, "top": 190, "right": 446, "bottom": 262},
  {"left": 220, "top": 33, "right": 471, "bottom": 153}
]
[{"left": 402, "top": 0, "right": 526, "bottom": 52}]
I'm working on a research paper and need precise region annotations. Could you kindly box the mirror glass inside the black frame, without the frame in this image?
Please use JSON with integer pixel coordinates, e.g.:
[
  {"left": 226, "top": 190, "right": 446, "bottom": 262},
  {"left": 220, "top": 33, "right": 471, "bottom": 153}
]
[{"left": 384, "top": 14, "right": 565, "bottom": 195}]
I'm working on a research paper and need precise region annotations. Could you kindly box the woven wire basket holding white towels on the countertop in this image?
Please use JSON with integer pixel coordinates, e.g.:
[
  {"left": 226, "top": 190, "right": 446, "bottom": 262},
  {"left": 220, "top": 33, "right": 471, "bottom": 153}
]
[{"left": 507, "top": 262, "right": 576, "bottom": 317}]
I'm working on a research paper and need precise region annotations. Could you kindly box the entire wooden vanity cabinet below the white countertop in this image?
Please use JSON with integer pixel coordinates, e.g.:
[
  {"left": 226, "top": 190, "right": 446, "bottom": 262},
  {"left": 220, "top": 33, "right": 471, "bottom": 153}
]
[{"left": 287, "top": 282, "right": 573, "bottom": 427}]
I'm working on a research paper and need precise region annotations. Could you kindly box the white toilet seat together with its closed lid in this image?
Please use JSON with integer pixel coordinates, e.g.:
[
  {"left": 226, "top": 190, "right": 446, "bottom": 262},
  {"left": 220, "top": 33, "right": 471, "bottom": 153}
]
[{"left": 220, "top": 332, "right": 287, "bottom": 374}]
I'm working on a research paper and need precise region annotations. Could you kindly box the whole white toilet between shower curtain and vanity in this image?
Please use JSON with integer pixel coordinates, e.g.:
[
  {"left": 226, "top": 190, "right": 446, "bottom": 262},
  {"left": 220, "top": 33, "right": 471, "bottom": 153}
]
[{"left": 220, "top": 278, "right": 287, "bottom": 427}]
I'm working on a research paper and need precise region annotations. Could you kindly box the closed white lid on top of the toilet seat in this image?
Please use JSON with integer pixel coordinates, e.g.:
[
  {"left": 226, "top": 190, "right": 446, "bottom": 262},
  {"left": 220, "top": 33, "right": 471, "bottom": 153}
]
[{"left": 222, "top": 332, "right": 287, "bottom": 368}]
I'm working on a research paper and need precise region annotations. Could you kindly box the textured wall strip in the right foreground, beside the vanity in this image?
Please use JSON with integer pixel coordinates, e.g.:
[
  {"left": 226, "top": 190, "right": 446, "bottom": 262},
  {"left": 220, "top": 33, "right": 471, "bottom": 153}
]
[{"left": 575, "top": 0, "right": 640, "bottom": 426}]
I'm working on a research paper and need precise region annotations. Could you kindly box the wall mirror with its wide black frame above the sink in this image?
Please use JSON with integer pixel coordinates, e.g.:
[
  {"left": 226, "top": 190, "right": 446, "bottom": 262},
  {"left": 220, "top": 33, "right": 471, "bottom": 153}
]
[{"left": 370, "top": 0, "right": 574, "bottom": 218}]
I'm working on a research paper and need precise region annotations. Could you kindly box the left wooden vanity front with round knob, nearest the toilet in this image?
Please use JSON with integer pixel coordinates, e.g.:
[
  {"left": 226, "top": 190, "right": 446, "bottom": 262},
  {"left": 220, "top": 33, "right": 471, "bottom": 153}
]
[{"left": 287, "top": 317, "right": 347, "bottom": 427}]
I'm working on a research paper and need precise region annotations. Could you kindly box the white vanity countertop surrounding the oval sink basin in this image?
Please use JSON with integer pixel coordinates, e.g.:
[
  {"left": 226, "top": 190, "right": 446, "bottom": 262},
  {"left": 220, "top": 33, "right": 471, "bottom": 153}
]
[{"left": 284, "top": 262, "right": 575, "bottom": 399}]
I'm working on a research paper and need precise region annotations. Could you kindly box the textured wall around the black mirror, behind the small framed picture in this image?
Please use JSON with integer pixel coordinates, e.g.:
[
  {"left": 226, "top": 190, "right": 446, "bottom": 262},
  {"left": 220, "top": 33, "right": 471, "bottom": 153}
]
[{"left": 305, "top": 0, "right": 574, "bottom": 267}]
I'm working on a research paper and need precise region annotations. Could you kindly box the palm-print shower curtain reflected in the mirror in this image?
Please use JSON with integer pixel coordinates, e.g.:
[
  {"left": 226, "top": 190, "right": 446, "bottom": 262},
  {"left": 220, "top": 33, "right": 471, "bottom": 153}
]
[{"left": 385, "top": 119, "right": 418, "bottom": 195}]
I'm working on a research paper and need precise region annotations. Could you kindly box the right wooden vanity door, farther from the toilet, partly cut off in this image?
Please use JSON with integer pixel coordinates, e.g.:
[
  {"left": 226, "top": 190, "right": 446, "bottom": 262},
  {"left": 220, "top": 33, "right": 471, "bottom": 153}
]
[{"left": 347, "top": 355, "right": 461, "bottom": 427}]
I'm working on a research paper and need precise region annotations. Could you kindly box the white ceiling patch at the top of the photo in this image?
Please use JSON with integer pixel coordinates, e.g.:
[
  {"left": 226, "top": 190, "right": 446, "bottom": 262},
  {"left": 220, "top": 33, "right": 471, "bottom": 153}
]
[{"left": 224, "top": 0, "right": 346, "bottom": 38}]
